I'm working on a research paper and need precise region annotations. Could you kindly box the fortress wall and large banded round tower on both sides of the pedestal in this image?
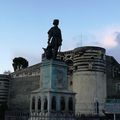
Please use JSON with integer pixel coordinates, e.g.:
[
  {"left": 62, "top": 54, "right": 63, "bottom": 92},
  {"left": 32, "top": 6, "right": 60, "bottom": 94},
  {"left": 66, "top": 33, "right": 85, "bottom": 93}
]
[{"left": 6, "top": 46, "right": 120, "bottom": 114}]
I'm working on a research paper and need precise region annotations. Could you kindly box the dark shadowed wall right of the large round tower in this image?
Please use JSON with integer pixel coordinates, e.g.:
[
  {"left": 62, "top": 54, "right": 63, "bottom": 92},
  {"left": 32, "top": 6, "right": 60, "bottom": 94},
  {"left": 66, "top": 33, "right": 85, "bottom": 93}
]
[{"left": 106, "top": 56, "right": 120, "bottom": 99}]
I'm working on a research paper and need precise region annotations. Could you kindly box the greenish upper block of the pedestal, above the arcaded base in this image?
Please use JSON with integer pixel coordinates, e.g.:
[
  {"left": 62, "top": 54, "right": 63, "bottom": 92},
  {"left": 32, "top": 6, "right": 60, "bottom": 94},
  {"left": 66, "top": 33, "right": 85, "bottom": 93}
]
[{"left": 40, "top": 60, "right": 68, "bottom": 90}]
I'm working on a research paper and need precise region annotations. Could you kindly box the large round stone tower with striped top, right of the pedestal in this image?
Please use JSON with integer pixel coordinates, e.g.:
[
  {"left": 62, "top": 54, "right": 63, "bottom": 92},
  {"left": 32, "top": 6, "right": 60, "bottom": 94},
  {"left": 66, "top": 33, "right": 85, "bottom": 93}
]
[{"left": 73, "top": 46, "right": 106, "bottom": 114}]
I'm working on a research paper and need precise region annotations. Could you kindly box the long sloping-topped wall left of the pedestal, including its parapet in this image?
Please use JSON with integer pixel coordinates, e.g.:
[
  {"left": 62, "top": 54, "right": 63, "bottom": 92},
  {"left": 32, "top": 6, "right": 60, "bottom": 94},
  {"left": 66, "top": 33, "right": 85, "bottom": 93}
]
[{"left": 9, "top": 64, "right": 40, "bottom": 111}]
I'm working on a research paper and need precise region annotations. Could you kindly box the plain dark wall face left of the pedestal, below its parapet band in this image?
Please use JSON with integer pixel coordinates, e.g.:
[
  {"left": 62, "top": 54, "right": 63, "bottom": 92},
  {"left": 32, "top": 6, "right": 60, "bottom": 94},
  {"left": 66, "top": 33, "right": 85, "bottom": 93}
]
[{"left": 9, "top": 76, "right": 40, "bottom": 111}]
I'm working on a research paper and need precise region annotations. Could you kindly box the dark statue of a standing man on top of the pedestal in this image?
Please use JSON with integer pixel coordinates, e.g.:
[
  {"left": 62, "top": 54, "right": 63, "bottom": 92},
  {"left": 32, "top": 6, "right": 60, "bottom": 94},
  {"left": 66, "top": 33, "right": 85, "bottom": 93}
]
[{"left": 48, "top": 19, "right": 62, "bottom": 59}]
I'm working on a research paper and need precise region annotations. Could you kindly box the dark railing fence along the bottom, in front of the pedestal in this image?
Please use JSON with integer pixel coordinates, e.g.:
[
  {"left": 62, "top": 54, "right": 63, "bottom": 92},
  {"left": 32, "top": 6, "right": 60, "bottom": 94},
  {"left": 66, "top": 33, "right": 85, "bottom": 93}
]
[{"left": 5, "top": 112, "right": 105, "bottom": 120}]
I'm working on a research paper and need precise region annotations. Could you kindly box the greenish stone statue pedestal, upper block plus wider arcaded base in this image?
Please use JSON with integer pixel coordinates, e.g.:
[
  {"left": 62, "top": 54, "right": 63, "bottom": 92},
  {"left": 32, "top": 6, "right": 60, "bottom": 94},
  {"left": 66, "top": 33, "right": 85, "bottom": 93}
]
[{"left": 30, "top": 60, "right": 75, "bottom": 113}]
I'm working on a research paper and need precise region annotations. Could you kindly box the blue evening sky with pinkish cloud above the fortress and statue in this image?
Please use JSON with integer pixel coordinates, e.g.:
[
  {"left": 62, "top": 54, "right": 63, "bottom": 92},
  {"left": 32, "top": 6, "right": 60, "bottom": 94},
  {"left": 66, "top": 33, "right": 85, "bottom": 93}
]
[{"left": 0, "top": 0, "right": 120, "bottom": 74}]
